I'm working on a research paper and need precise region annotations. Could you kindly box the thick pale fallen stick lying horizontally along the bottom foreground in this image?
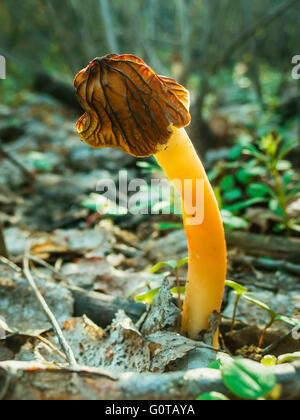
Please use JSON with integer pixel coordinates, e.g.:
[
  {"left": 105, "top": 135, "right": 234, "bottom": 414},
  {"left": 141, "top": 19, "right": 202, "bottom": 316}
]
[{"left": 0, "top": 361, "right": 300, "bottom": 401}]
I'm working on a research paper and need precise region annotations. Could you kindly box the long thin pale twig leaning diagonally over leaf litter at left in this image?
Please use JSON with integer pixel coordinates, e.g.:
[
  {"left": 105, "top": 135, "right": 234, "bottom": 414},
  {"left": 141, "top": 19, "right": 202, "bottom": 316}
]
[{"left": 23, "top": 252, "right": 77, "bottom": 367}]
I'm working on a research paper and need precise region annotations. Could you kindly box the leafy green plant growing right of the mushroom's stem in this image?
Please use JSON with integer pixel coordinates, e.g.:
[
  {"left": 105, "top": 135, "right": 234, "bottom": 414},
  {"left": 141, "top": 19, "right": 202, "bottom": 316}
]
[{"left": 208, "top": 132, "right": 300, "bottom": 234}]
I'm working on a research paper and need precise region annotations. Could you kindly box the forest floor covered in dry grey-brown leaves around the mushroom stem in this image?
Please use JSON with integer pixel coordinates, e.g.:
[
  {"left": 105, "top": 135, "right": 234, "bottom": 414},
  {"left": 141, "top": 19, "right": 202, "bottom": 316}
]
[{"left": 0, "top": 95, "right": 300, "bottom": 398}]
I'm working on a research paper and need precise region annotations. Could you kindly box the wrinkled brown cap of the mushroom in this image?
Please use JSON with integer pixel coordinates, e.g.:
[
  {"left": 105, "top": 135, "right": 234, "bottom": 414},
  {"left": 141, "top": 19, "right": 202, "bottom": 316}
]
[{"left": 74, "top": 54, "right": 191, "bottom": 157}]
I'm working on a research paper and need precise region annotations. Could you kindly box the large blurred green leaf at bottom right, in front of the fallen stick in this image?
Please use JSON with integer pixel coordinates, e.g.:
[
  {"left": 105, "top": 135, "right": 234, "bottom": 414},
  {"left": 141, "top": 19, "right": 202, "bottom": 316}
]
[{"left": 221, "top": 359, "right": 277, "bottom": 400}]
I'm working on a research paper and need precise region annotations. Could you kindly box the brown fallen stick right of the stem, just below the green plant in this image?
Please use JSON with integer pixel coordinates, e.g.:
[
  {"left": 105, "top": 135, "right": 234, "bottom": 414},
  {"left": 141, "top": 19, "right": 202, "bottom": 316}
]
[{"left": 226, "top": 232, "right": 300, "bottom": 261}]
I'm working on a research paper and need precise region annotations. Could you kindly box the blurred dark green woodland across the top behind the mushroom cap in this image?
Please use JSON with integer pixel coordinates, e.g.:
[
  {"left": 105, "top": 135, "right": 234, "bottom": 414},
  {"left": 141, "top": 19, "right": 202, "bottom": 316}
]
[{"left": 0, "top": 0, "right": 300, "bottom": 149}]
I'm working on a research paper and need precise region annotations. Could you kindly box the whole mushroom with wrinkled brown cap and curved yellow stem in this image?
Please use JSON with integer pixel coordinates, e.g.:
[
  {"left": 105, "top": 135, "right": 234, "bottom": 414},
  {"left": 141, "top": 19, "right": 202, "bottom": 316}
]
[{"left": 74, "top": 54, "right": 226, "bottom": 345}]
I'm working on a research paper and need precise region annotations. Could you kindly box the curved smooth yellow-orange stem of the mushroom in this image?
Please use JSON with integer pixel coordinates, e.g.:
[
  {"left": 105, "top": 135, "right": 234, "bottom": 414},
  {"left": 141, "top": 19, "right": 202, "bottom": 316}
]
[{"left": 155, "top": 128, "right": 226, "bottom": 346}]
